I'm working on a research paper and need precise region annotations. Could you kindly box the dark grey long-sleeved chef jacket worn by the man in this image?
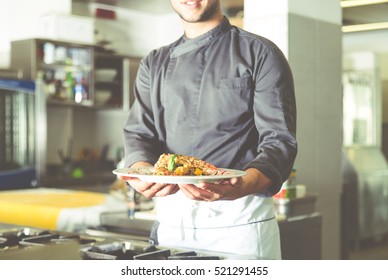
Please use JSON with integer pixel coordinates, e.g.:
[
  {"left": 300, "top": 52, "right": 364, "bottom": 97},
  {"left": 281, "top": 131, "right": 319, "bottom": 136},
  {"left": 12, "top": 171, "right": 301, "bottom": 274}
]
[{"left": 124, "top": 17, "right": 297, "bottom": 196}]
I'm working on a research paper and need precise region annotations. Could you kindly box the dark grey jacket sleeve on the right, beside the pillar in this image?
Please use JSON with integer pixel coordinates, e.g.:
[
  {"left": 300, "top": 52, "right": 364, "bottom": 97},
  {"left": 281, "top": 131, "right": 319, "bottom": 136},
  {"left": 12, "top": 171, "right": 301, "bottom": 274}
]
[{"left": 246, "top": 46, "right": 297, "bottom": 195}]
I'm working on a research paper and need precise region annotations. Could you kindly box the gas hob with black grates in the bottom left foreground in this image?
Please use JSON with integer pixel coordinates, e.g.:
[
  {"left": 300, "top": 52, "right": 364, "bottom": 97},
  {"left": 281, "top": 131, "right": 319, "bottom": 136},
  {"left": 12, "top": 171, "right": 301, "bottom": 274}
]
[{"left": 0, "top": 226, "right": 234, "bottom": 260}]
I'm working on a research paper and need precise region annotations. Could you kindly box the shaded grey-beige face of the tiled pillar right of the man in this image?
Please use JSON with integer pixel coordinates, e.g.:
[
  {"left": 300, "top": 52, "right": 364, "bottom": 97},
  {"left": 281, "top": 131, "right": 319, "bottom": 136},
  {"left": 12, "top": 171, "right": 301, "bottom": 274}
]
[{"left": 289, "top": 15, "right": 342, "bottom": 259}]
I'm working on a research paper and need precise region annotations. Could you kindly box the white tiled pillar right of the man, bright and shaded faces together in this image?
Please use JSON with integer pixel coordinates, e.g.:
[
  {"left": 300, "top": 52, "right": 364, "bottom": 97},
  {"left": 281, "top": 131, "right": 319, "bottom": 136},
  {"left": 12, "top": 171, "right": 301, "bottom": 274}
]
[{"left": 244, "top": 0, "right": 342, "bottom": 259}]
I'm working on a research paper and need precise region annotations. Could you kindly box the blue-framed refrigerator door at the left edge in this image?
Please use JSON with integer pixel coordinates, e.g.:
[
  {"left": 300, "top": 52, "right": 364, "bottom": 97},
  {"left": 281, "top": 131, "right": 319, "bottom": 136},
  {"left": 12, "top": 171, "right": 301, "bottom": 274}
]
[{"left": 0, "top": 79, "right": 37, "bottom": 189}]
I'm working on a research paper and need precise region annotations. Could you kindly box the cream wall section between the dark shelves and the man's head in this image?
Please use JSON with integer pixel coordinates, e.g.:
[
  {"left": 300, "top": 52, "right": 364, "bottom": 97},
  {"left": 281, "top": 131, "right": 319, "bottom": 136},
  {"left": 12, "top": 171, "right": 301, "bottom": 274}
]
[{"left": 72, "top": 2, "right": 182, "bottom": 56}]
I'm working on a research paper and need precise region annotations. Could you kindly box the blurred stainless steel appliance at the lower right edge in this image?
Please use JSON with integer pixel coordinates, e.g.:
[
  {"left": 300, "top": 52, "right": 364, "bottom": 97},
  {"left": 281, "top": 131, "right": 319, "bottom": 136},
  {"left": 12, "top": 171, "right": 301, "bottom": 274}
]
[{"left": 342, "top": 147, "right": 388, "bottom": 246}]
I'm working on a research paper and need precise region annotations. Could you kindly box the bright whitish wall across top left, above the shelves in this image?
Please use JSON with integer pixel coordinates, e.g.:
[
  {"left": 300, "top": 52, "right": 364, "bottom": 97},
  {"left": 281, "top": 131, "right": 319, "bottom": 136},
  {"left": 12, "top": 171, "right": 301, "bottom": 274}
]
[{"left": 0, "top": 0, "right": 182, "bottom": 68}]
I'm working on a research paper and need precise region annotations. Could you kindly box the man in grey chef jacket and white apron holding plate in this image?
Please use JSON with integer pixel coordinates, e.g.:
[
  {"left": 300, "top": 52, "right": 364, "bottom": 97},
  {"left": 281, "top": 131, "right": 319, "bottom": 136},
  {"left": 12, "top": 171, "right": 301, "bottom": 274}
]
[{"left": 123, "top": 0, "right": 297, "bottom": 259}]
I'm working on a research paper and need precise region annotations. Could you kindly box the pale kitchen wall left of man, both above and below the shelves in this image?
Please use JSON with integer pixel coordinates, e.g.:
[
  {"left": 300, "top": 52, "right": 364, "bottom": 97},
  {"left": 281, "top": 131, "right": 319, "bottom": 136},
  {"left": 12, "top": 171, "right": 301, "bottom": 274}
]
[{"left": 0, "top": 0, "right": 182, "bottom": 164}]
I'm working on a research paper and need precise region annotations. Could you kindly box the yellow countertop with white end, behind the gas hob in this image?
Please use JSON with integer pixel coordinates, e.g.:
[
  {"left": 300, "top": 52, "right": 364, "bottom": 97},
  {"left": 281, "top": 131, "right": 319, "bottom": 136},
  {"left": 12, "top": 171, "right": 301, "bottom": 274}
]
[{"left": 0, "top": 188, "right": 127, "bottom": 231}]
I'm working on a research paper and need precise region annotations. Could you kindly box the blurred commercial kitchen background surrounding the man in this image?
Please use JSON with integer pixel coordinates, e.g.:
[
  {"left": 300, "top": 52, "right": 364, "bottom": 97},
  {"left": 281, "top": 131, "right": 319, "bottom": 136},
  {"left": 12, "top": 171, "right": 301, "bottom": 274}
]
[{"left": 0, "top": 0, "right": 388, "bottom": 260}]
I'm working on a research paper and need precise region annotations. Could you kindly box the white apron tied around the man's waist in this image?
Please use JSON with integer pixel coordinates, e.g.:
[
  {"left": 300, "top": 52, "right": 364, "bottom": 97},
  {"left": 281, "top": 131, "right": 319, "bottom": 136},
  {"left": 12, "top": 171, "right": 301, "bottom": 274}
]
[{"left": 155, "top": 192, "right": 281, "bottom": 259}]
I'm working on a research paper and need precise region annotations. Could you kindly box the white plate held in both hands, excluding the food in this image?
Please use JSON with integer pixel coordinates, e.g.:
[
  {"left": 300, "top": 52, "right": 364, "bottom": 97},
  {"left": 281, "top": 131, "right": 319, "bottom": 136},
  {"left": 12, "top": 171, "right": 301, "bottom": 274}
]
[{"left": 113, "top": 166, "right": 246, "bottom": 184}]
